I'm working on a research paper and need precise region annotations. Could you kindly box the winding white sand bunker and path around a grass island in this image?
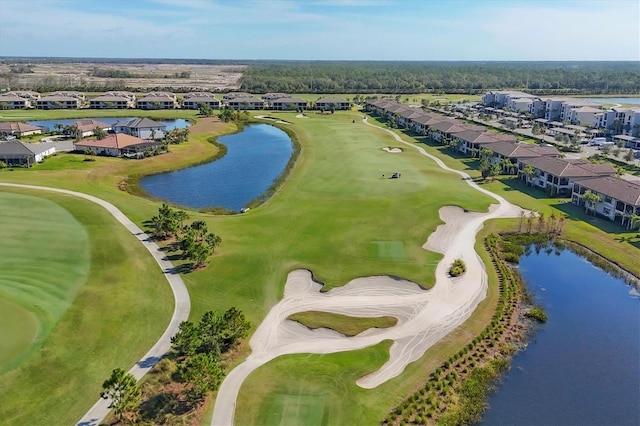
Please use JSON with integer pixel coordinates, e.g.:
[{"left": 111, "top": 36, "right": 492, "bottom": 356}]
[{"left": 212, "top": 118, "right": 521, "bottom": 425}]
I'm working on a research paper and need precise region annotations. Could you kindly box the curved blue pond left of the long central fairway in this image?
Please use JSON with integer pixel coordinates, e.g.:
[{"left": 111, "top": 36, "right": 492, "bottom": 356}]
[{"left": 140, "top": 124, "right": 293, "bottom": 211}]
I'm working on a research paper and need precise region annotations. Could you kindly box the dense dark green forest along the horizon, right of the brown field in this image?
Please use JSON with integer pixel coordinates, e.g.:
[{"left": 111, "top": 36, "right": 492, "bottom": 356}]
[{"left": 240, "top": 61, "right": 640, "bottom": 94}]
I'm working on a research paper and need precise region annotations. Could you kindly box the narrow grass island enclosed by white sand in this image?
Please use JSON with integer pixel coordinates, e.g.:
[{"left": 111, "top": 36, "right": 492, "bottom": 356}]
[{"left": 287, "top": 311, "right": 398, "bottom": 336}]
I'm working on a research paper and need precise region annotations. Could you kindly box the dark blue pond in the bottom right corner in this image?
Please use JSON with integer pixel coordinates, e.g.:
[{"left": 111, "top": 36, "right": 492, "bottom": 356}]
[{"left": 483, "top": 250, "right": 640, "bottom": 425}]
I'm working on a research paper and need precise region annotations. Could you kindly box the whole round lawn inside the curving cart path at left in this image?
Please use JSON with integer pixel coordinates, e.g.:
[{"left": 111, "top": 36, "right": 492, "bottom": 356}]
[{"left": 0, "top": 191, "right": 173, "bottom": 425}]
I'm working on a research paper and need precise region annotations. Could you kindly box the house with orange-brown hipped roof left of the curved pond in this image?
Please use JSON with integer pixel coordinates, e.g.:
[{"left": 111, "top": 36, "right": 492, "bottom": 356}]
[{"left": 73, "top": 133, "right": 163, "bottom": 158}]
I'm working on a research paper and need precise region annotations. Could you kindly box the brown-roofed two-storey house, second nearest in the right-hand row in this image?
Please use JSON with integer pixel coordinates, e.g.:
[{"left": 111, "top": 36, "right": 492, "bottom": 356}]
[{"left": 518, "top": 156, "right": 616, "bottom": 197}]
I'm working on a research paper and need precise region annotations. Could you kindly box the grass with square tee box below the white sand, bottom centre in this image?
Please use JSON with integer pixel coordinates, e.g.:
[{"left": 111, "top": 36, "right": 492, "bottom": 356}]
[{"left": 235, "top": 341, "right": 396, "bottom": 426}]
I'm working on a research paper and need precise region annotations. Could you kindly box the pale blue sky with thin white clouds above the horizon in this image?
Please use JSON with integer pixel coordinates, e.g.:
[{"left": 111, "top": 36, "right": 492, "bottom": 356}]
[{"left": 0, "top": 0, "right": 640, "bottom": 61}]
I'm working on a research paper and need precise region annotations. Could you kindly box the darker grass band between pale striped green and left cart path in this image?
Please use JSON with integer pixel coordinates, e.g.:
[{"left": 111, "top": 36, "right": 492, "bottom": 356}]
[{"left": 0, "top": 188, "right": 173, "bottom": 426}]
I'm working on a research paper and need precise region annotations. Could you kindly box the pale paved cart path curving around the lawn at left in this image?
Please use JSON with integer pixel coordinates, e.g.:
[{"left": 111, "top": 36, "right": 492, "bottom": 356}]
[{"left": 0, "top": 182, "right": 191, "bottom": 426}]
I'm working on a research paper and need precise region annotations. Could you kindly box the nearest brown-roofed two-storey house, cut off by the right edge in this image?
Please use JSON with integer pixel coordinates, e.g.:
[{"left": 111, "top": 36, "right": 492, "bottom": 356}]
[{"left": 571, "top": 176, "right": 640, "bottom": 226}]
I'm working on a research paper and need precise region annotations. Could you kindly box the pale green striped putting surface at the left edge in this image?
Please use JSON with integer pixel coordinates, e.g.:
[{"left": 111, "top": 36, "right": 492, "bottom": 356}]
[{"left": 0, "top": 193, "right": 89, "bottom": 372}]
